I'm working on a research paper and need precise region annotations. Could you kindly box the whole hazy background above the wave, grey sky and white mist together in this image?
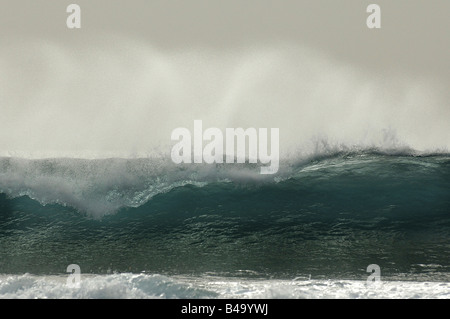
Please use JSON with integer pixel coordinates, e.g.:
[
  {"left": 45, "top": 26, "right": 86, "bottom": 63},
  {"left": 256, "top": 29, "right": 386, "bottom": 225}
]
[{"left": 0, "top": 0, "right": 450, "bottom": 155}]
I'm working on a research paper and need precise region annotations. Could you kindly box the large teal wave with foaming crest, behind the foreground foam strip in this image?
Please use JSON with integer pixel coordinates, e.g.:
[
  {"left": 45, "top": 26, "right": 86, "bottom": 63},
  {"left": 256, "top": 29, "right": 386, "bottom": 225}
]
[{"left": 0, "top": 151, "right": 450, "bottom": 281}]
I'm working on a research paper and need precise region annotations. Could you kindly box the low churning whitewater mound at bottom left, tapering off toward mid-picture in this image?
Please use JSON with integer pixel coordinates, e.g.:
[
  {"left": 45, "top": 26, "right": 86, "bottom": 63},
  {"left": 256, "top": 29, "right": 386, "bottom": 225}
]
[{"left": 0, "top": 274, "right": 216, "bottom": 299}]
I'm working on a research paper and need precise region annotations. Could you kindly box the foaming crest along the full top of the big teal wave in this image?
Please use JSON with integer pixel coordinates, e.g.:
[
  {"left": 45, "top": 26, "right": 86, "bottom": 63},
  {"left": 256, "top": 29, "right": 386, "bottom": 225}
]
[{"left": 0, "top": 152, "right": 450, "bottom": 218}]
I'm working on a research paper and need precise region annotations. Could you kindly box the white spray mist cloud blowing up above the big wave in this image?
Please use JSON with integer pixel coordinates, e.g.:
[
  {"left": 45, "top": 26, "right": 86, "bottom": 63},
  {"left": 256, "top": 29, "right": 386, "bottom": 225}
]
[{"left": 0, "top": 37, "right": 450, "bottom": 158}]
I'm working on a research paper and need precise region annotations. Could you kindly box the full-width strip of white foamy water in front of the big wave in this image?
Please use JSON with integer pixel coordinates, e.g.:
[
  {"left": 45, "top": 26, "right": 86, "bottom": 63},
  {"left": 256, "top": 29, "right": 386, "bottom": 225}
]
[{"left": 0, "top": 273, "right": 450, "bottom": 299}]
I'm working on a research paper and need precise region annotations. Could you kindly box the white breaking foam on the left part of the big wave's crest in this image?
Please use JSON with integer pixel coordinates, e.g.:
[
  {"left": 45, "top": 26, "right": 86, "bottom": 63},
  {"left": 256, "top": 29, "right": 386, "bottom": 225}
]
[{"left": 0, "top": 158, "right": 271, "bottom": 218}]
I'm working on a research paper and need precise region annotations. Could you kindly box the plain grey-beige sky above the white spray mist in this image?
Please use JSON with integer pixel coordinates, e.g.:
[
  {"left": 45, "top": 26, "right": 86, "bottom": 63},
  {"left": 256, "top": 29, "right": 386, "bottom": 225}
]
[{"left": 0, "top": 0, "right": 450, "bottom": 80}]
